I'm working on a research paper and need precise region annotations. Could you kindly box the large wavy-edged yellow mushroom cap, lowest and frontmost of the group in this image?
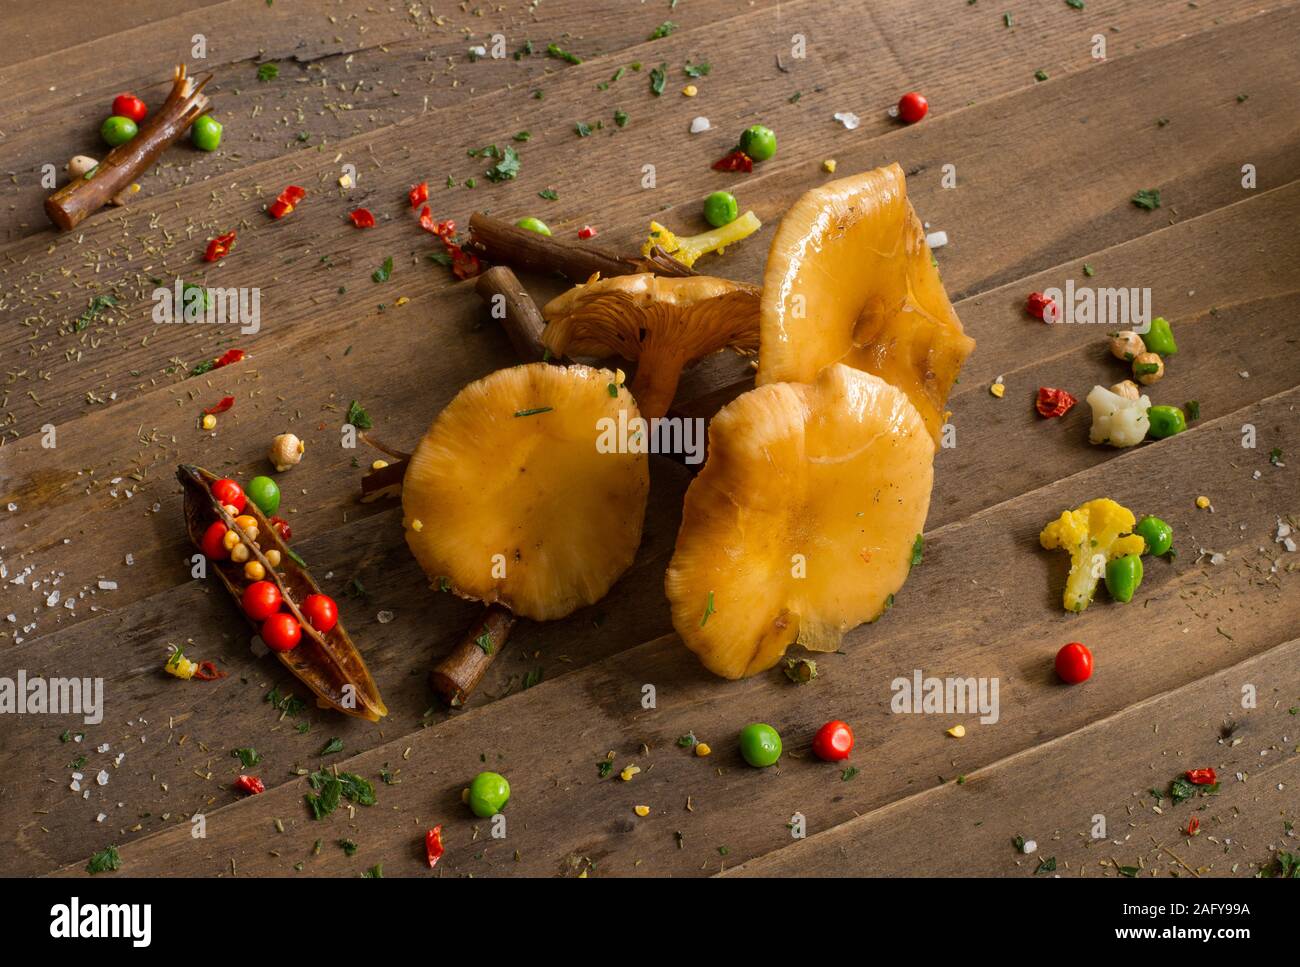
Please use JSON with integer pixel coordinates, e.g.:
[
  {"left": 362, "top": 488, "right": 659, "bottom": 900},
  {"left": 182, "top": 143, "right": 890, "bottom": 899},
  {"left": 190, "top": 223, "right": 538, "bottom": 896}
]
[{"left": 664, "top": 365, "right": 935, "bottom": 678}]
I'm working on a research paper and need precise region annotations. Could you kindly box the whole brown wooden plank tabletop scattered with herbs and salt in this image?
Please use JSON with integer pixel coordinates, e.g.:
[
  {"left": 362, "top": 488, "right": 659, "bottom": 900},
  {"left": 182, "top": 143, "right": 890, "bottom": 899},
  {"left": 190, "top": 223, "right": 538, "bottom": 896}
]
[{"left": 0, "top": 0, "right": 1300, "bottom": 876}]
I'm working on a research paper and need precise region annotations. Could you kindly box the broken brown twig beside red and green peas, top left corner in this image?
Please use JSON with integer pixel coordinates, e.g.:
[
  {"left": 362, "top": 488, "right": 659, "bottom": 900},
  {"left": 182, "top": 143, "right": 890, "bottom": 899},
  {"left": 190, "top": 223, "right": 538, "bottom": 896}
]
[{"left": 46, "top": 64, "right": 212, "bottom": 231}]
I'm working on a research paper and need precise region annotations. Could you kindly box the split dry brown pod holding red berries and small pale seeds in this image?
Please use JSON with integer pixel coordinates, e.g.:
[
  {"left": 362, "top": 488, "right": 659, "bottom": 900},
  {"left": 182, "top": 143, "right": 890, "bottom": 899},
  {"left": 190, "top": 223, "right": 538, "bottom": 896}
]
[{"left": 177, "top": 464, "right": 389, "bottom": 721}]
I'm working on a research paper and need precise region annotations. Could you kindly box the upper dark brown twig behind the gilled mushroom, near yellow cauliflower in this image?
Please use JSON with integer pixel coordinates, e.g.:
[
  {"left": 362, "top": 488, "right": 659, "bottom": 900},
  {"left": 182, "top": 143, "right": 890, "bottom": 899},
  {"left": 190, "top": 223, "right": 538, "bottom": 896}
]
[{"left": 465, "top": 212, "right": 696, "bottom": 282}]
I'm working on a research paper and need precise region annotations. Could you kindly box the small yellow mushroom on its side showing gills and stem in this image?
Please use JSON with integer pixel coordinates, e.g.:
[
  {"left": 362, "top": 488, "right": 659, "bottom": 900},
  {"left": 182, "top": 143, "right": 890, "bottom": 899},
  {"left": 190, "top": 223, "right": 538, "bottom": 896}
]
[{"left": 542, "top": 272, "right": 758, "bottom": 419}]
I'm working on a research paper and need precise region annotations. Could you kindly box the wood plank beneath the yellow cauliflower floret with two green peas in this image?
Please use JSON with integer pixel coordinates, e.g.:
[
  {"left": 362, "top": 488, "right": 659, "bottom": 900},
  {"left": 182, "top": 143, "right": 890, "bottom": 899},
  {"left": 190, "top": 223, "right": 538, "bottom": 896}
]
[{"left": 32, "top": 390, "right": 1300, "bottom": 875}]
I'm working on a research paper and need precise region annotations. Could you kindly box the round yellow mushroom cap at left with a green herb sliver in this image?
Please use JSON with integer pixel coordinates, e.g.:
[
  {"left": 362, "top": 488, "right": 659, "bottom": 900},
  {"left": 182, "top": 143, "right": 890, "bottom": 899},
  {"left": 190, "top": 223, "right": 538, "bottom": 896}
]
[{"left": 402, "top": 363, "right": 650, "bottom": 620}]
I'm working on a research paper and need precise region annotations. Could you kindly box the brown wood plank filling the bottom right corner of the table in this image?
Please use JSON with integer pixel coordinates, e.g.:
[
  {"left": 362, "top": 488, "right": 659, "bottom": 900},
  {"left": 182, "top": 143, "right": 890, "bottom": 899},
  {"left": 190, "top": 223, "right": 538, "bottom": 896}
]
[{"left": 728, "top": 641, "right": 1300, "bottom": 876}]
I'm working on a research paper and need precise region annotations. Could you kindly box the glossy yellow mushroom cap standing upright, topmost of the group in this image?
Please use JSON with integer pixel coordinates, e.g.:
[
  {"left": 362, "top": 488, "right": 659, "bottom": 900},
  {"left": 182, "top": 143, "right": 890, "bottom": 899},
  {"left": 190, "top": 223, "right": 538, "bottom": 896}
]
[{"left": 757, "top": 164, "right": 975, "bottom": 442}]
